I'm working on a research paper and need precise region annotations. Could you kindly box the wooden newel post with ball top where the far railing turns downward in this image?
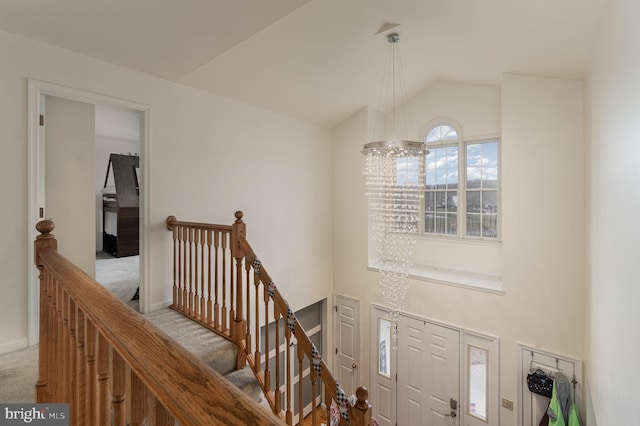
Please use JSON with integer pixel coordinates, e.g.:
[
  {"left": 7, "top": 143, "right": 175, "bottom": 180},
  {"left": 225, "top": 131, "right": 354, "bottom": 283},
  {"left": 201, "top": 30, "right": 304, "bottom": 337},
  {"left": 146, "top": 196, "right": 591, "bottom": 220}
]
[{"left": 231, "top": 210, "right": 249, "bottom": 368}]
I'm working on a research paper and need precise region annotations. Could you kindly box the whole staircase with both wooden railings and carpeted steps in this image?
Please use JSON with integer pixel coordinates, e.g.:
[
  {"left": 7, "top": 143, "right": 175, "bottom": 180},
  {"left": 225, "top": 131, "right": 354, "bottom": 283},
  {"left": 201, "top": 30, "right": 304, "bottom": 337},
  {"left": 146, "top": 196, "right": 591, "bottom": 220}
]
[{"left": 34, "top": 216, "right": 376, "bottom": 426}]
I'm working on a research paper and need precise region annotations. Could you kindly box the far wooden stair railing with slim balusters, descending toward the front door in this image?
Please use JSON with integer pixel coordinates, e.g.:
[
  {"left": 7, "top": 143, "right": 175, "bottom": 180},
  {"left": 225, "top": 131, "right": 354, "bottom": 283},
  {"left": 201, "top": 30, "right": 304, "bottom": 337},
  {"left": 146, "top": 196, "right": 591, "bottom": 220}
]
[{"left": 167, "top": 211, "right": 371, "bottom": 426}]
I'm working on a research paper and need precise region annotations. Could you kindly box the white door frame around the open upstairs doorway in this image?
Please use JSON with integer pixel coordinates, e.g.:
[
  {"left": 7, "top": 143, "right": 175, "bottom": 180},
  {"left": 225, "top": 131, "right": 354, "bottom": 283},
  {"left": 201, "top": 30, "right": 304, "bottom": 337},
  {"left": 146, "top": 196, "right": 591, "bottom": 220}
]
[{"left": 27, "top": 79, "right": 151, "bottom": 346}]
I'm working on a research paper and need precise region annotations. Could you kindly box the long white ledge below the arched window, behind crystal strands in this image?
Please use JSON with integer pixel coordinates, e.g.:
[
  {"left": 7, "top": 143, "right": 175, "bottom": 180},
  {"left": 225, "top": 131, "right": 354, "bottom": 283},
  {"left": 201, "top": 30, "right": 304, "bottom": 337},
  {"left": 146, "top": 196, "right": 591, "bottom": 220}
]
[{"left": 367, "top": 264, "right": 504, "bottom": 294}]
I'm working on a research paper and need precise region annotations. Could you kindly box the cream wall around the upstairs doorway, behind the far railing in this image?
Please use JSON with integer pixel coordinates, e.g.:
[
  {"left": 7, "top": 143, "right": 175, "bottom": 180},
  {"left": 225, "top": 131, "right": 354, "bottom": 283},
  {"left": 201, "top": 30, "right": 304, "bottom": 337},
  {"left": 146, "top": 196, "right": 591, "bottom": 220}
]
[{"left": 0, "top": 29, "right": 333, "bottom": 352}]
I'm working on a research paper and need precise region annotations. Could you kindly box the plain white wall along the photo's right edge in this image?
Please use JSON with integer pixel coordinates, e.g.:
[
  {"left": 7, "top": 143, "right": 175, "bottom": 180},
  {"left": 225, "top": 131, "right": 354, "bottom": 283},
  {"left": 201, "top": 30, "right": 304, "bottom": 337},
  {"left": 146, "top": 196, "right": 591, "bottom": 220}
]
[{"left": 586, "top": 0, "right": 640, "bottom": 426}]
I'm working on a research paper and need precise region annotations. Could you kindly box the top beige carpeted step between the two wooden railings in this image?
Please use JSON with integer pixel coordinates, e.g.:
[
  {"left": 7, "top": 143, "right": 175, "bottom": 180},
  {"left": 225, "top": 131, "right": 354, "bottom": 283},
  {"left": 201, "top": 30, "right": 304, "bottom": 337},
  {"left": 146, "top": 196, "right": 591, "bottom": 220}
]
[{"left": 144, "top": 308, "right": 236, "bottom": 376}]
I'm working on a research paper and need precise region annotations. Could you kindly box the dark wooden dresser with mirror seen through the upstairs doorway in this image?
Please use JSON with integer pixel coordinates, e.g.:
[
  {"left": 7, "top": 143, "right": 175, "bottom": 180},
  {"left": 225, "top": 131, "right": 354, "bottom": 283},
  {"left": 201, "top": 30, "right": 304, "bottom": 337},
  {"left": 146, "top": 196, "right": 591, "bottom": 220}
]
[{"left": 102, "top": 154, "right": 140, "bottom": 257}]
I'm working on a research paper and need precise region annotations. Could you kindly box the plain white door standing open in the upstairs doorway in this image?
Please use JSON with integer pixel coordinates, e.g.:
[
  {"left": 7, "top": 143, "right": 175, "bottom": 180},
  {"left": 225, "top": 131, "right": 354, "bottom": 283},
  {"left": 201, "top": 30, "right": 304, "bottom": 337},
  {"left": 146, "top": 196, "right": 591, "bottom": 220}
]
[{"left": 44, "top": 96, "right": 96, "bottom": 276}]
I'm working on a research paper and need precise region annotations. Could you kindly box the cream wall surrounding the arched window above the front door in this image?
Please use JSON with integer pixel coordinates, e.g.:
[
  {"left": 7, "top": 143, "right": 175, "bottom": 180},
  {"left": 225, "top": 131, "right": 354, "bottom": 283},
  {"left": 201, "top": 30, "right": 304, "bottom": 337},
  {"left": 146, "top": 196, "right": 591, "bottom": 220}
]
[{"left": 334, "top": 75, "right": 585, "bottom": 425}]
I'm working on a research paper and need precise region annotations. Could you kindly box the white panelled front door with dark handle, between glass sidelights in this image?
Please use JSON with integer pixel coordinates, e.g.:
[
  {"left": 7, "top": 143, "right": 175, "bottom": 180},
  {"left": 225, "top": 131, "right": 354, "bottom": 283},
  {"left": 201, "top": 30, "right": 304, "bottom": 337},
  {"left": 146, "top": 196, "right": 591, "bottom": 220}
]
[{"left": 397, "top": 315, "right": 460, "bottom": 426}]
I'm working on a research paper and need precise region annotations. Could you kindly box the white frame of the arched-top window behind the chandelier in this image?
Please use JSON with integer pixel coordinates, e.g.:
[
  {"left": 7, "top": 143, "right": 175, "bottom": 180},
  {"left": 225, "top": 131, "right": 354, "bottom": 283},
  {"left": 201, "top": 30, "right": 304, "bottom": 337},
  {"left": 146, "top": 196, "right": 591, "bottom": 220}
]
[{"left": 419, "top": 119, "right": 502, "bottom": 242}]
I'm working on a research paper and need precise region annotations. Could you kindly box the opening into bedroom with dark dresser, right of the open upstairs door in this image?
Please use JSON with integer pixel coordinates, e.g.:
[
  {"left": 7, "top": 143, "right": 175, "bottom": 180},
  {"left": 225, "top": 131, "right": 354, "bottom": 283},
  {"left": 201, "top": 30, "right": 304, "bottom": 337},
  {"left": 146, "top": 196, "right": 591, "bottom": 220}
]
[{"left": 95, "top": 105, "right": 141, "bottom": 310}]
